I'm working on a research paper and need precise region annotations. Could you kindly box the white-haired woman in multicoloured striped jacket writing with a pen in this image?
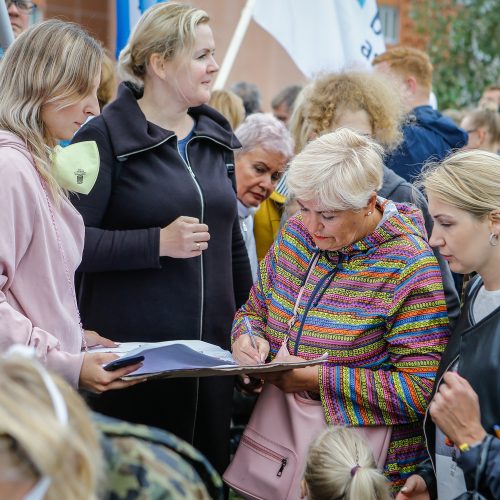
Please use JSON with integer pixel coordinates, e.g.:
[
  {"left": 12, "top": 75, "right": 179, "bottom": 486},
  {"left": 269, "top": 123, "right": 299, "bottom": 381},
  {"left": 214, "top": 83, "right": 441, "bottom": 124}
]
[{"left": 232, "top": 129, "right": 448, "bottom": 488}]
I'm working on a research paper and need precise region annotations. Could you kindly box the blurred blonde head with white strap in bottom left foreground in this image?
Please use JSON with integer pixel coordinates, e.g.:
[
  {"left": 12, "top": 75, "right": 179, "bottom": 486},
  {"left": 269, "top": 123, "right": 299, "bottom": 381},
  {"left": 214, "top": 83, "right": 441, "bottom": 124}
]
[{"left": 0, "top": 355, "right": 104, "bottom": 500}]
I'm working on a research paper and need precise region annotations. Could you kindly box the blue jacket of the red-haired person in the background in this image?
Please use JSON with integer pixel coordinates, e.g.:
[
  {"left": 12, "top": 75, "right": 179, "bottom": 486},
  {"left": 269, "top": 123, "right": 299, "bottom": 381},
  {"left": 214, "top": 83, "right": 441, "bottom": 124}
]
[{"left": 385, "top": 106, "right": 468, "bottom": 182}]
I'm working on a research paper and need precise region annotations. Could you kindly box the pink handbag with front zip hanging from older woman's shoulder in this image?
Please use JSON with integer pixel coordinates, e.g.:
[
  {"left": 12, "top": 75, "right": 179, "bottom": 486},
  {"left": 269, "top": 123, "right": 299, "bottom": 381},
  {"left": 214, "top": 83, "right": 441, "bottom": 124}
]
[{"left": 223, "top": 384, "right": 392, "bottom": 500}]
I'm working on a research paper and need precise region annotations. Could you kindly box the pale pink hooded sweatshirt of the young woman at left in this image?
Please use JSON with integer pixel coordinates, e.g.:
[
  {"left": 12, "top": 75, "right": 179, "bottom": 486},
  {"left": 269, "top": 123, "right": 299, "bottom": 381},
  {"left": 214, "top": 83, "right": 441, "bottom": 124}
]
[{"left": 0, "top": 130, "right": 84, "bottom": 388}]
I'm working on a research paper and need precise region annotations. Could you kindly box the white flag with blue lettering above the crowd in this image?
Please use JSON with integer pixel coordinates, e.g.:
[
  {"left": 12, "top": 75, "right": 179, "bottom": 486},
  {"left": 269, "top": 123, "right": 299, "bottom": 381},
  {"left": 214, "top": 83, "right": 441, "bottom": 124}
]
[{"left": 253, "top": 0, "right": 385, "bottom": 78}]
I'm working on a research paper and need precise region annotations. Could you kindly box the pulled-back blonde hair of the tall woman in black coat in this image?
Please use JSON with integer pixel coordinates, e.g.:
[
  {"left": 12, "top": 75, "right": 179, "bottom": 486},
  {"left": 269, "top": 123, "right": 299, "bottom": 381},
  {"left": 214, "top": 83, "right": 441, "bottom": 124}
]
[{"left": 118, "top": 2, "right": 210, "bottom": 88}]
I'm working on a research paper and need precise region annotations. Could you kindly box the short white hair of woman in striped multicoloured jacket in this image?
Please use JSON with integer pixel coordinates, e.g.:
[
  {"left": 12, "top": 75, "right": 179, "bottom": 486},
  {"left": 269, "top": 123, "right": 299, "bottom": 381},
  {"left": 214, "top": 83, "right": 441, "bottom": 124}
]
[{"left": 287, "top": 128, "right": 384, "bottom": 210}]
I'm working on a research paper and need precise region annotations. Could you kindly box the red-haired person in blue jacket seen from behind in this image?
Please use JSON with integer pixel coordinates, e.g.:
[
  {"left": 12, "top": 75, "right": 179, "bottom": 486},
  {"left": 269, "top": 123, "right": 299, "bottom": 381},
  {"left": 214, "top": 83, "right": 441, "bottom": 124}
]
[{"left": 373, "top": 47, "right": 467, "bottom": 182}]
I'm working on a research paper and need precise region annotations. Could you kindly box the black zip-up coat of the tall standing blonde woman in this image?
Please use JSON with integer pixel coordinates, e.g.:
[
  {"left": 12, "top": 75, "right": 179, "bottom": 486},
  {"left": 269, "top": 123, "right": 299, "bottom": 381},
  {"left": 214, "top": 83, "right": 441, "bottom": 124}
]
[{"left": 72, "top": 84, "right": 252, "bottom": 469}]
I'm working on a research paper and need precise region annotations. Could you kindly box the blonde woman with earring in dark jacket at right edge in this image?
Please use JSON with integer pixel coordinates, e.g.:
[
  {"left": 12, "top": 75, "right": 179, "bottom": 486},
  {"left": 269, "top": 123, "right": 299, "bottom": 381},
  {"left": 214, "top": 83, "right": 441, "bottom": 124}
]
[{"left": 397, "top": 150, "right": 500, "bottom": 500}]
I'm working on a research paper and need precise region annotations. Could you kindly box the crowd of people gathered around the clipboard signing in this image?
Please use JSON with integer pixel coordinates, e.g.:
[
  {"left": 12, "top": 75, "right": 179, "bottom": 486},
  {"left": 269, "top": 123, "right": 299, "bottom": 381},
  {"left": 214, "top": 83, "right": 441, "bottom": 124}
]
[{"left": 0, "top": 0, "right": 500, "bottom": 500}]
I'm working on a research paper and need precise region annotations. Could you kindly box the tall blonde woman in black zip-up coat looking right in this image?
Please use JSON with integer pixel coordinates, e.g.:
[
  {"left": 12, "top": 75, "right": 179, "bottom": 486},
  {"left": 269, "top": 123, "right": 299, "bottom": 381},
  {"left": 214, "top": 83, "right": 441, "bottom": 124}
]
[{"left": 73, "top": 2, "right": 251, "bottom": 472}]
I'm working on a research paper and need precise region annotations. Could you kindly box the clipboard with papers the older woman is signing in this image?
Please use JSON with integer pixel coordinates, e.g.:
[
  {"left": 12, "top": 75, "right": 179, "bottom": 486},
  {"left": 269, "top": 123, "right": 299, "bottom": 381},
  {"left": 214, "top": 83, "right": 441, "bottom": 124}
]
[{"left": 99, "top": 340, "right": 328, "bottom": 380}]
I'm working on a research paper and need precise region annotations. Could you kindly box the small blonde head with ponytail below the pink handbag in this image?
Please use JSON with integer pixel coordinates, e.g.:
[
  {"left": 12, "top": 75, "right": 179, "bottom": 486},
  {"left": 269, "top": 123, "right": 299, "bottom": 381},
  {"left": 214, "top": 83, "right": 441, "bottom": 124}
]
[{"left": 302, "top": 427, "right": 391, "bottom": 500}]
